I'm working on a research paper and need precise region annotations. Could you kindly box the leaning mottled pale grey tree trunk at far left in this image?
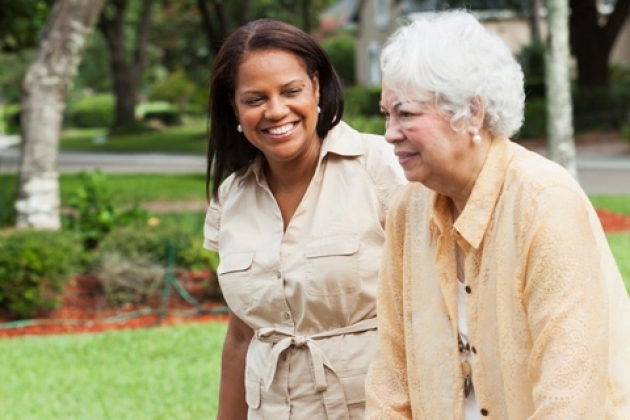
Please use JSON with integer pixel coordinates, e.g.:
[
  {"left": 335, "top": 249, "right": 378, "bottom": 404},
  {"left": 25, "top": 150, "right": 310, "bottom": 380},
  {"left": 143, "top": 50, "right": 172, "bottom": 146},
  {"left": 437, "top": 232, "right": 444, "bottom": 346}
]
[{"left": 15, "top": 0, "right": 104, "bottom": 229}]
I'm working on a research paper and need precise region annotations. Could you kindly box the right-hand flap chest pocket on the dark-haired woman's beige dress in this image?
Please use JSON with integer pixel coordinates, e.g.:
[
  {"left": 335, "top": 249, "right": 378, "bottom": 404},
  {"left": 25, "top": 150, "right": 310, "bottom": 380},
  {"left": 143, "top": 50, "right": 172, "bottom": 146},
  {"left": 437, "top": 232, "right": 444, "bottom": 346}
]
[{"left": 306, "top": 235, "right": 361, "bottom": 296}]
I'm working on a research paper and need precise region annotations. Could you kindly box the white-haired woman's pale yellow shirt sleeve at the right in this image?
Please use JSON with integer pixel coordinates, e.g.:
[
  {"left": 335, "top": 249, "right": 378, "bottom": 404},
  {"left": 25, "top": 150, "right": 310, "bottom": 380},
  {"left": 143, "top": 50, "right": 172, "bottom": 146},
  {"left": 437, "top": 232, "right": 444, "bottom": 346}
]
[{"left": 524, "top": 187, "right": 609, "bottom": 419}]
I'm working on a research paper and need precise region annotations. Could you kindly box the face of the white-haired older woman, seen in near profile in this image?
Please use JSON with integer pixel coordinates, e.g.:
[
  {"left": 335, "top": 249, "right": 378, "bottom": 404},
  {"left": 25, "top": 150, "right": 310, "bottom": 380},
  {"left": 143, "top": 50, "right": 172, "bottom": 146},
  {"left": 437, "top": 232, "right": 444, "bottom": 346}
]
[{"left": 381, "top": 88, "right": 471, "bottom": 191}]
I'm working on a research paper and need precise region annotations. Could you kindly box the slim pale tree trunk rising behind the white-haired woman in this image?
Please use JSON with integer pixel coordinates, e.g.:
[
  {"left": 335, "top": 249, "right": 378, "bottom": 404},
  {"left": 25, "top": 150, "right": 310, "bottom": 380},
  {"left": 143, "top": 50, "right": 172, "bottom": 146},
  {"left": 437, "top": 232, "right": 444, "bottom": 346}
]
[{"left": 545, "top": 0, "right": 578, "bottom": 179}]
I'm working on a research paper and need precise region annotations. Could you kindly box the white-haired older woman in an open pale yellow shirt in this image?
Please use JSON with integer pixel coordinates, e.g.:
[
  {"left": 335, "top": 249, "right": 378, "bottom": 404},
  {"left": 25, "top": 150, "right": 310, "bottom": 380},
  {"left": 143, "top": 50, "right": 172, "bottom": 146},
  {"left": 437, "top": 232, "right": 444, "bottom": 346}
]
[{"left": 366, "top": 11, "right": 630, "bottom": 420}]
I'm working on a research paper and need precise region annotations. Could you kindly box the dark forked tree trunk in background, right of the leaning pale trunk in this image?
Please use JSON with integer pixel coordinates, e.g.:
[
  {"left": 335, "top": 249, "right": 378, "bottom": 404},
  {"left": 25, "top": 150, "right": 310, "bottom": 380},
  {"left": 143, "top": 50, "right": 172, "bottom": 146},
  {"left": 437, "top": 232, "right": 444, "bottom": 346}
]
[{"left": 98, "top": 0, "right": 153, "bottom": 127}]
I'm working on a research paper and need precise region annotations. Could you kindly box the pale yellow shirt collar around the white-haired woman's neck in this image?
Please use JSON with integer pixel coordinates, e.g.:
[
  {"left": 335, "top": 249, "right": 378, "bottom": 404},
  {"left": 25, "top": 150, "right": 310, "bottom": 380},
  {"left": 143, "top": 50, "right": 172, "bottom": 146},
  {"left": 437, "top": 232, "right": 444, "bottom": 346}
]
[{"left": 430, "top": 137, "right": 510, "bottom": 248}]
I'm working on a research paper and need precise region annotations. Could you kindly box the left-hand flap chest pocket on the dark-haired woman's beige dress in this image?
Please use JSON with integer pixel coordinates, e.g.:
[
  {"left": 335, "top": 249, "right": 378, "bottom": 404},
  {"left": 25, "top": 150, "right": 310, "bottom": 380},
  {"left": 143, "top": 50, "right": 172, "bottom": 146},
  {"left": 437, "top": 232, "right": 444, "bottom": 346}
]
[{"left": 217, "top": 252, "right": 256, "bottom": 311}]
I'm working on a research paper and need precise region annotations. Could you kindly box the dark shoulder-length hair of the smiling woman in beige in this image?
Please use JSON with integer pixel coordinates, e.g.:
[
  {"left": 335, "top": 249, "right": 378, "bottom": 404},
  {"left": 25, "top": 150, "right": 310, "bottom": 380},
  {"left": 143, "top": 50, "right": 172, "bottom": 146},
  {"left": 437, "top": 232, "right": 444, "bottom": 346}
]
[{"left": 206, "top": 19, "right": 343, "bottom": 199}]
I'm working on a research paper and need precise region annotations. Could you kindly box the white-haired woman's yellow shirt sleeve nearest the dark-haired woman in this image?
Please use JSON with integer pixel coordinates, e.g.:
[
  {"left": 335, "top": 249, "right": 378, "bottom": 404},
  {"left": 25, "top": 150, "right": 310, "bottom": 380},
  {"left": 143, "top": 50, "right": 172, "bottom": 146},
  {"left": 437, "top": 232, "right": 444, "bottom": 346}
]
[{"left": 365, "top": 190, "right": 412, "bottom": 420}]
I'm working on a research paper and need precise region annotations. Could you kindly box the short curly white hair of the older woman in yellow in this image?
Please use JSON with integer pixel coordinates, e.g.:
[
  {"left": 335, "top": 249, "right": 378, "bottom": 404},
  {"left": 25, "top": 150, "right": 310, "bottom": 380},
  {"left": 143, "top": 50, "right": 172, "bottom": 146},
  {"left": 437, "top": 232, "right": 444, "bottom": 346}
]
[{"left": 381, "top": 10, "right": 525, "bottom": 137}]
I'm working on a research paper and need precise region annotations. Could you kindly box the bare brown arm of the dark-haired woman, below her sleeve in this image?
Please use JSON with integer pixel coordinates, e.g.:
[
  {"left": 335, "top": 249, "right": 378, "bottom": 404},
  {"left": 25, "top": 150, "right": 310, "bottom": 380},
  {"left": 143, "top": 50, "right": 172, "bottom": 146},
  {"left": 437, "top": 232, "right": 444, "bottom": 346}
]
[{"left": 217, "top": 313, "right": 254, "bottom": 420}]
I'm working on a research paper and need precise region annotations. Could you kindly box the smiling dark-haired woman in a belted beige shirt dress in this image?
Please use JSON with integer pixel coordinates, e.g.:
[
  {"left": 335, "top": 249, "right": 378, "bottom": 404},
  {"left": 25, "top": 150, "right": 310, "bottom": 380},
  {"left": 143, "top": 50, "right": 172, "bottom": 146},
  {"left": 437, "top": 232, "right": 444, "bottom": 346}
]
[{"left": 205, "top": 19, "right": 406, "bottom": 420}]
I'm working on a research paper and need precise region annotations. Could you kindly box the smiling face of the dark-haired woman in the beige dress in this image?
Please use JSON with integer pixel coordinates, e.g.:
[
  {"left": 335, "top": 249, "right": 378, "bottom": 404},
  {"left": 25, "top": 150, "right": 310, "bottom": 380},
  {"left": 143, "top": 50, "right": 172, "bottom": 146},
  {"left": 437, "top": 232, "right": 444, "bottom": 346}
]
[{"left": 234, "top": 50, "right": 321, "bottom": 163}]
